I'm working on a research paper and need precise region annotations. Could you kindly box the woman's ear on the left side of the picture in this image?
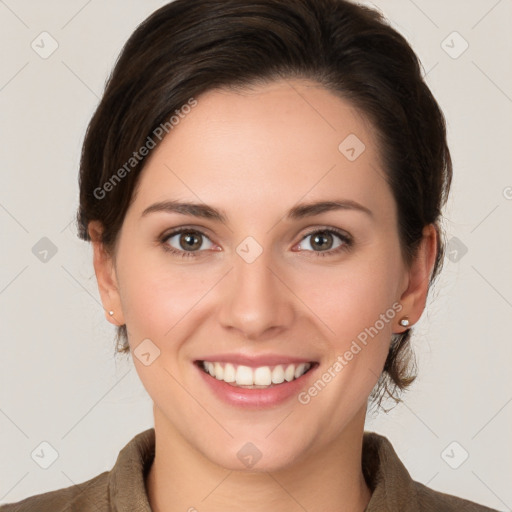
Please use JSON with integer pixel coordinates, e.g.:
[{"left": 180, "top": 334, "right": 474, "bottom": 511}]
[{"left": 88, "top": 221, "right": 125, "bottom": 325}]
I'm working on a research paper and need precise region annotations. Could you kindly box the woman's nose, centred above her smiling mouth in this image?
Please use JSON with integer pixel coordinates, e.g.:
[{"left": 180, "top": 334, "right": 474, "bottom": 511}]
[{"left": 219, "top": 243, "right": 297, "bottom": 340}]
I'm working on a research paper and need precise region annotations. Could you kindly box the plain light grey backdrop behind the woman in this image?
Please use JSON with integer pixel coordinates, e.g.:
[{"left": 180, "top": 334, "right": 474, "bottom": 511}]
[{"left": 0, "top": 0, "right": 512, "bottom": 510}]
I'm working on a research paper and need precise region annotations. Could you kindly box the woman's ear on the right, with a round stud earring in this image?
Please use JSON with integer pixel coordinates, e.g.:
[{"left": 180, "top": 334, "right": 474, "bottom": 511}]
[{"left": 398, "top": 224, "right": 439, "bottom": 333}]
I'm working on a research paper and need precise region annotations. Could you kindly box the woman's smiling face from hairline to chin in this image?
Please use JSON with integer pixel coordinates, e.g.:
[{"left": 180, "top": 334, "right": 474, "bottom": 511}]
[{"left": 91, "top": 80, "right": 431, "bottom": 470}]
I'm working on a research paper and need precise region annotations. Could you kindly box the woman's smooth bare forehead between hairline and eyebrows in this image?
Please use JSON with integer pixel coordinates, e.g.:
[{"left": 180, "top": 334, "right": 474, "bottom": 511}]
[{"left": 134, "top": 80, "right": 392, "bottom": 224}]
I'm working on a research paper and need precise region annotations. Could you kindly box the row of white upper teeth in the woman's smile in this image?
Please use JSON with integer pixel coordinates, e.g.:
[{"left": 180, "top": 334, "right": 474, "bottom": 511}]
[{"left": 202, "top": 361, "right": 311, "bottom": 386}]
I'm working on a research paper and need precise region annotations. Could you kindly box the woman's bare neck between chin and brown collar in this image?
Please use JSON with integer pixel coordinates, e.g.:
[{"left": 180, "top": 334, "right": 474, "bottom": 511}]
[{"left": 146, "top": 406, "right": 371, "bottom": 512}]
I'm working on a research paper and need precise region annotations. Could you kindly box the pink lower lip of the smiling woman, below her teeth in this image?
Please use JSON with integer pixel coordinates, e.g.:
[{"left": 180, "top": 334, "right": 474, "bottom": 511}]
[{"left": 194, "top": 364, "right": 318, "bottom": 408}]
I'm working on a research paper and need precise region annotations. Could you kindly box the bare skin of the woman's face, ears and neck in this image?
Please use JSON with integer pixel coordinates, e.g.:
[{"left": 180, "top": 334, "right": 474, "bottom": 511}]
[{"left": 89, "top": 80, "right": 437, "bottom": 512}]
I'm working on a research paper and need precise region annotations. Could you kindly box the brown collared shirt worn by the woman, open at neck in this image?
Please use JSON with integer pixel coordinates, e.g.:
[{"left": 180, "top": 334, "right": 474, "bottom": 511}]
[{"left": 0, "top": 428, "right": 496, "bottom": 512}]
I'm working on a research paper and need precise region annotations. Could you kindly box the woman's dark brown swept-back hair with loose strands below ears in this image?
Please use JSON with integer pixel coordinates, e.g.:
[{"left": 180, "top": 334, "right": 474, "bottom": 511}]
[{"left": 77, "top": 0, "right": 452, "bottom": 403}]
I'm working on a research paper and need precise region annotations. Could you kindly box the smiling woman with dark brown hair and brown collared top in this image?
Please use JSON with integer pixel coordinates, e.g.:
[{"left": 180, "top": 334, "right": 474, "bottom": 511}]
[{"left": 1, "top": 0, "right": 500, "bottom": 512}]
